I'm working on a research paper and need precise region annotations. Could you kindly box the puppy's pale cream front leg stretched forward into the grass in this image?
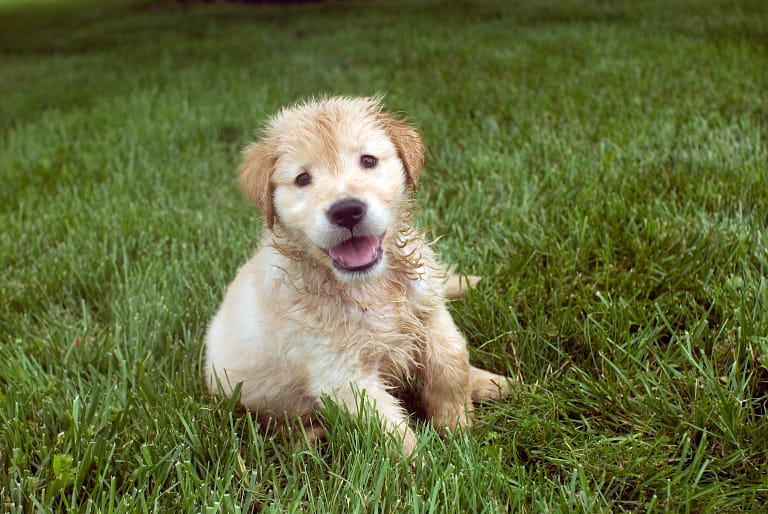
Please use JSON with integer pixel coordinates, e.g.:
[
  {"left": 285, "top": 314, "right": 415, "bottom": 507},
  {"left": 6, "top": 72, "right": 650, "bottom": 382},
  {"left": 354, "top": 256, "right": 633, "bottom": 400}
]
[{"left": 333, "top": 377, "right": 416, "bottom": 455}]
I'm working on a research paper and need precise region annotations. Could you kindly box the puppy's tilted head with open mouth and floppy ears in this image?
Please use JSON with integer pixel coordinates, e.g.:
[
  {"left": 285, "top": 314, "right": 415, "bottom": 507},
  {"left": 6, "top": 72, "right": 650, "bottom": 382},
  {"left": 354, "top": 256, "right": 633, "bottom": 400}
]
[{"left": 240, "top": 97, "right": 424, "bottom": 281}]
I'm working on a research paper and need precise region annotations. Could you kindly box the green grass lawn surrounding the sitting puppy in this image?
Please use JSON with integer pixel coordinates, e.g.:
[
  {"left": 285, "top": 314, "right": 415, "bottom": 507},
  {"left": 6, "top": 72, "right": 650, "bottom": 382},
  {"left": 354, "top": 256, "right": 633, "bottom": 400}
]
[{"left": 0, "top": 0, "right": 768, "bottom": 513}]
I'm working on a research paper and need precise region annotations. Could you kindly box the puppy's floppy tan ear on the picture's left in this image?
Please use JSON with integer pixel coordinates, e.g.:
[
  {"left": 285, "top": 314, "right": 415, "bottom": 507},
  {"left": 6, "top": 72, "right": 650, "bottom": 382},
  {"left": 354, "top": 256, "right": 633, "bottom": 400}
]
[{"left": 239, "top": 142, "right": 277, "bottom": 229}]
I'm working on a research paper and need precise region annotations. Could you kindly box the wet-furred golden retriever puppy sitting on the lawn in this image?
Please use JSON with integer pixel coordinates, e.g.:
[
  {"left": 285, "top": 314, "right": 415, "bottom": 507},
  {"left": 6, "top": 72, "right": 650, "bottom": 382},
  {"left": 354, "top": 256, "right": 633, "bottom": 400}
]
[{"left": 205, "top": 97, "right": 508, "bottom": 454}]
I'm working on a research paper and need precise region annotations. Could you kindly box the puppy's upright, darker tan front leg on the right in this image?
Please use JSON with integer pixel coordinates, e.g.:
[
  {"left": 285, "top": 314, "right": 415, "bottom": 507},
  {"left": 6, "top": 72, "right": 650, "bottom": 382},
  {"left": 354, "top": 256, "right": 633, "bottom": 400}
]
[{"left": 420, "top": 306, "right": 473, "bottom": 431}]
